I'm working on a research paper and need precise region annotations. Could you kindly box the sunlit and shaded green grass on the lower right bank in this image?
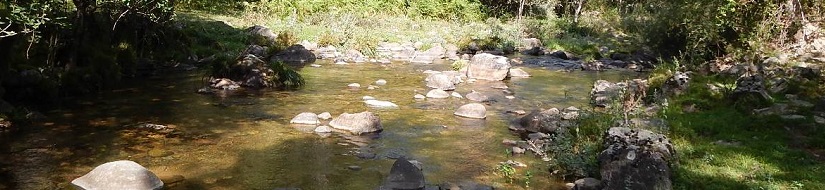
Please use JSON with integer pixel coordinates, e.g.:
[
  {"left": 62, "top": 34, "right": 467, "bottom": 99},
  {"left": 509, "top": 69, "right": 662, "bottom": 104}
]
[{"left": 667, "top": 107, "right": 825, "bottom": 189}]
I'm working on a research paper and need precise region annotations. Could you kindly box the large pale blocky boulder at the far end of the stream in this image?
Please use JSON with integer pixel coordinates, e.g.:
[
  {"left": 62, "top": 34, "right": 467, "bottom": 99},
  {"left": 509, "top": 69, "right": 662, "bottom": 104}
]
[{"left": 467, "top": 53, "right": 510, "bottom": 81}]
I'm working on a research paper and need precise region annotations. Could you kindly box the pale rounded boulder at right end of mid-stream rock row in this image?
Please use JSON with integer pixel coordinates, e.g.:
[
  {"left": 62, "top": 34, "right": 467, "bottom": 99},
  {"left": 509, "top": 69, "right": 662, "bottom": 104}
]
[{"left": 329, "top": 111, "right": 384, "bottom": 135}]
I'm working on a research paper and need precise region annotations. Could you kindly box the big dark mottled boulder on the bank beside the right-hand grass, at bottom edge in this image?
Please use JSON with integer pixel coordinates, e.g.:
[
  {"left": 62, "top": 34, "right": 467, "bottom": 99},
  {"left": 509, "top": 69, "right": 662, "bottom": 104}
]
[{"left": 598, "top": 127, "right": 676, "bottom": 190}]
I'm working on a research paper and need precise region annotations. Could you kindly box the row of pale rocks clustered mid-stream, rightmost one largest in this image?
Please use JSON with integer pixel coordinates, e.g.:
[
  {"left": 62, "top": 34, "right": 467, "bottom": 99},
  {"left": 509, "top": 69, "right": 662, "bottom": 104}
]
[{"left": 289, "top": 111, "right": 384, "bottom": 135}]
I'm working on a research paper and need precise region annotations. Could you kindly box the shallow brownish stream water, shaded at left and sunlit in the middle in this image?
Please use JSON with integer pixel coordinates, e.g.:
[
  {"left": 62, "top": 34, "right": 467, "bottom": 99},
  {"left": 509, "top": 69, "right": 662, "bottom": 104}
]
[{"left": 0, "top": 59, "right": 636, "bottom": 189}]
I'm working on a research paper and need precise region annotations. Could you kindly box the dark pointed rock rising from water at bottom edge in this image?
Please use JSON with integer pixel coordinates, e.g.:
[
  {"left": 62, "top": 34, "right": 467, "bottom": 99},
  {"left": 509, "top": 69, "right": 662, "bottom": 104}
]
[{"left": 379, "top": 157, "right": 426, "bottom": 190}]
